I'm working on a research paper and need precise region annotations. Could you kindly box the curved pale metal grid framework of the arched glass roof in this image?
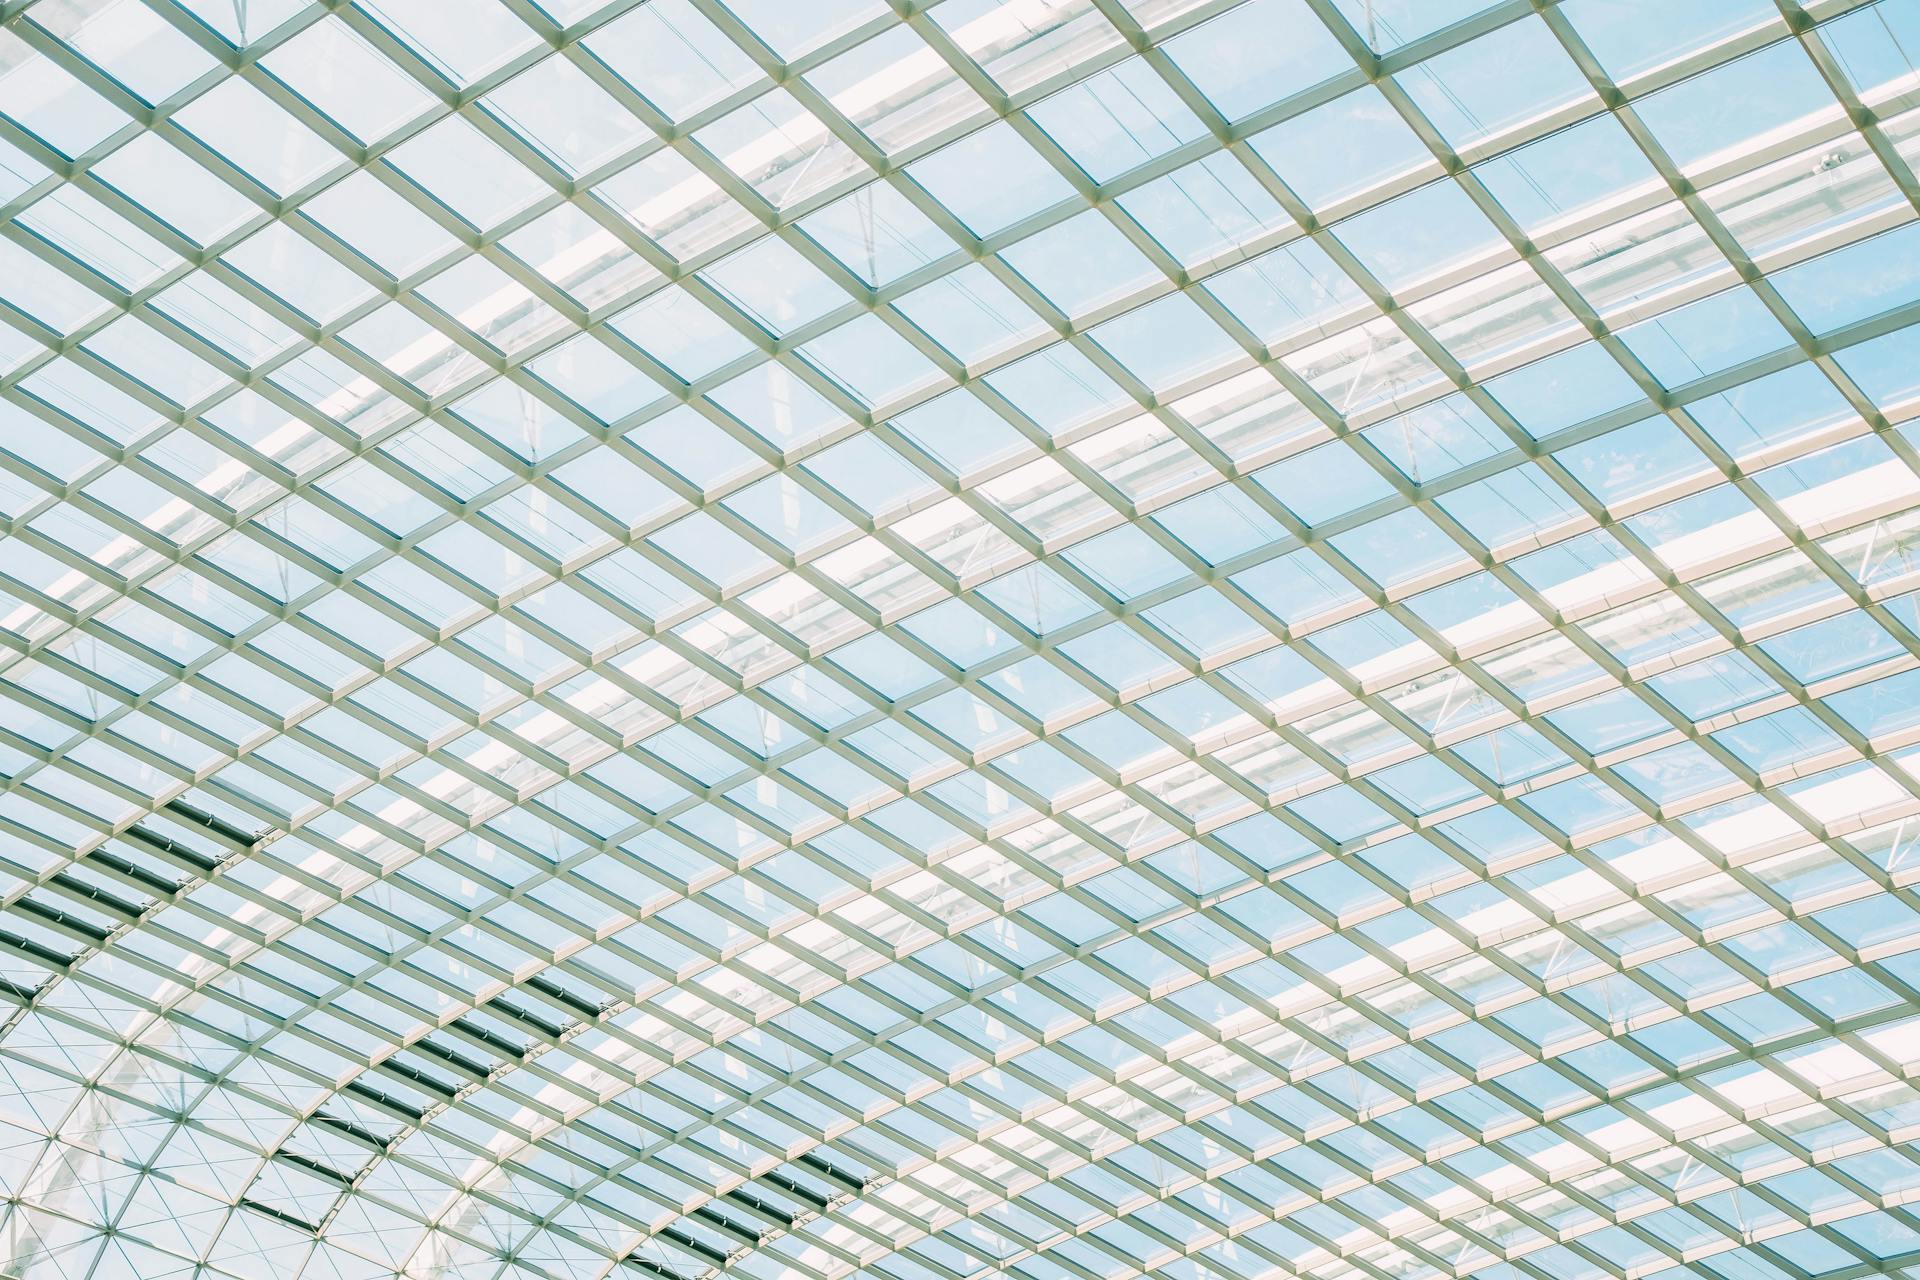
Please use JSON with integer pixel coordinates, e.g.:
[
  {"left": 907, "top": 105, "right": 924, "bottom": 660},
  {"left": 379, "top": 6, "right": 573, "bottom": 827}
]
[{"left": 0, "top": 0, "right": 1920, "bottom": 1280}]
